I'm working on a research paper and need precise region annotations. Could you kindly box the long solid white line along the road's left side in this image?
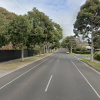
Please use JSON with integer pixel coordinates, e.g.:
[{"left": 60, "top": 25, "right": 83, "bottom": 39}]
[{"left": 0, "top": 58, "right": 49, "bottom": 90}]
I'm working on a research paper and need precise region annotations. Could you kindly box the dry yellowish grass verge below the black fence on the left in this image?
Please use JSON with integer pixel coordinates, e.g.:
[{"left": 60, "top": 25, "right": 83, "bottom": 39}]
[{"left": 0, "top": 53, "right": 53, "bottom": 69}]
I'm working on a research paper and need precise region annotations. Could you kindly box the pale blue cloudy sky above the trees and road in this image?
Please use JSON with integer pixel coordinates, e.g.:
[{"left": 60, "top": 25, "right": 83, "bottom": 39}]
[{"left": 0, "top": 0, "right": 86, "bottom": 38}]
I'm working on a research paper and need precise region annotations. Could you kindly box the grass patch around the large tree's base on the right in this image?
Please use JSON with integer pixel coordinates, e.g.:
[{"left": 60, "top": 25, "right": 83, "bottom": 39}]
[{"left": 81, "top": 58, "right": 100, "bottom": 71}]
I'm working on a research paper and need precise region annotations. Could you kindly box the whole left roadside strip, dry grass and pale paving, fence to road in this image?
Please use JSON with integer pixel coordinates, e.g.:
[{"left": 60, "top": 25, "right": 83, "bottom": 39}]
[{"left": 0, "top": 53, "right": 53, "bottom": 78}]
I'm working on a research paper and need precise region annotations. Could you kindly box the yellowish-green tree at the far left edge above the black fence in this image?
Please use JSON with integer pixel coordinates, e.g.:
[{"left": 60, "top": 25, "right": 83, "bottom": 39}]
[{"left": 0, "top": 7, "right": 16, "bottom": 47}]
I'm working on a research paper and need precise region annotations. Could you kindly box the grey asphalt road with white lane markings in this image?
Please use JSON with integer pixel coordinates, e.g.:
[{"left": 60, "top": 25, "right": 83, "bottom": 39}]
[{"left": 0, "top": 49, "right": 100, "bottom": 100}]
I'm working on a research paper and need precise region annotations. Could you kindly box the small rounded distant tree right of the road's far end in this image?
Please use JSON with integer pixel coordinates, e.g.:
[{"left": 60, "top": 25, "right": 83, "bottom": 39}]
[{"left": 62, "top": 36, "right": 76, "bottom": 53}]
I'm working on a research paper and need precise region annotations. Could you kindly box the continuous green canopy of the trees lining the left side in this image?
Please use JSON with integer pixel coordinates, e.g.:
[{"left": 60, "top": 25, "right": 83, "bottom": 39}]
[{"left": 0, "top": 8, "right": 62, "bottom": 49}]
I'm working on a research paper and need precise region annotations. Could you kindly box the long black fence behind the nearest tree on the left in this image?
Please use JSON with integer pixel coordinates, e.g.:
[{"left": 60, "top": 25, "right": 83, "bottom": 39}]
[{"left": 0, "top": 50, "right": 33, "bottom": 62}]
